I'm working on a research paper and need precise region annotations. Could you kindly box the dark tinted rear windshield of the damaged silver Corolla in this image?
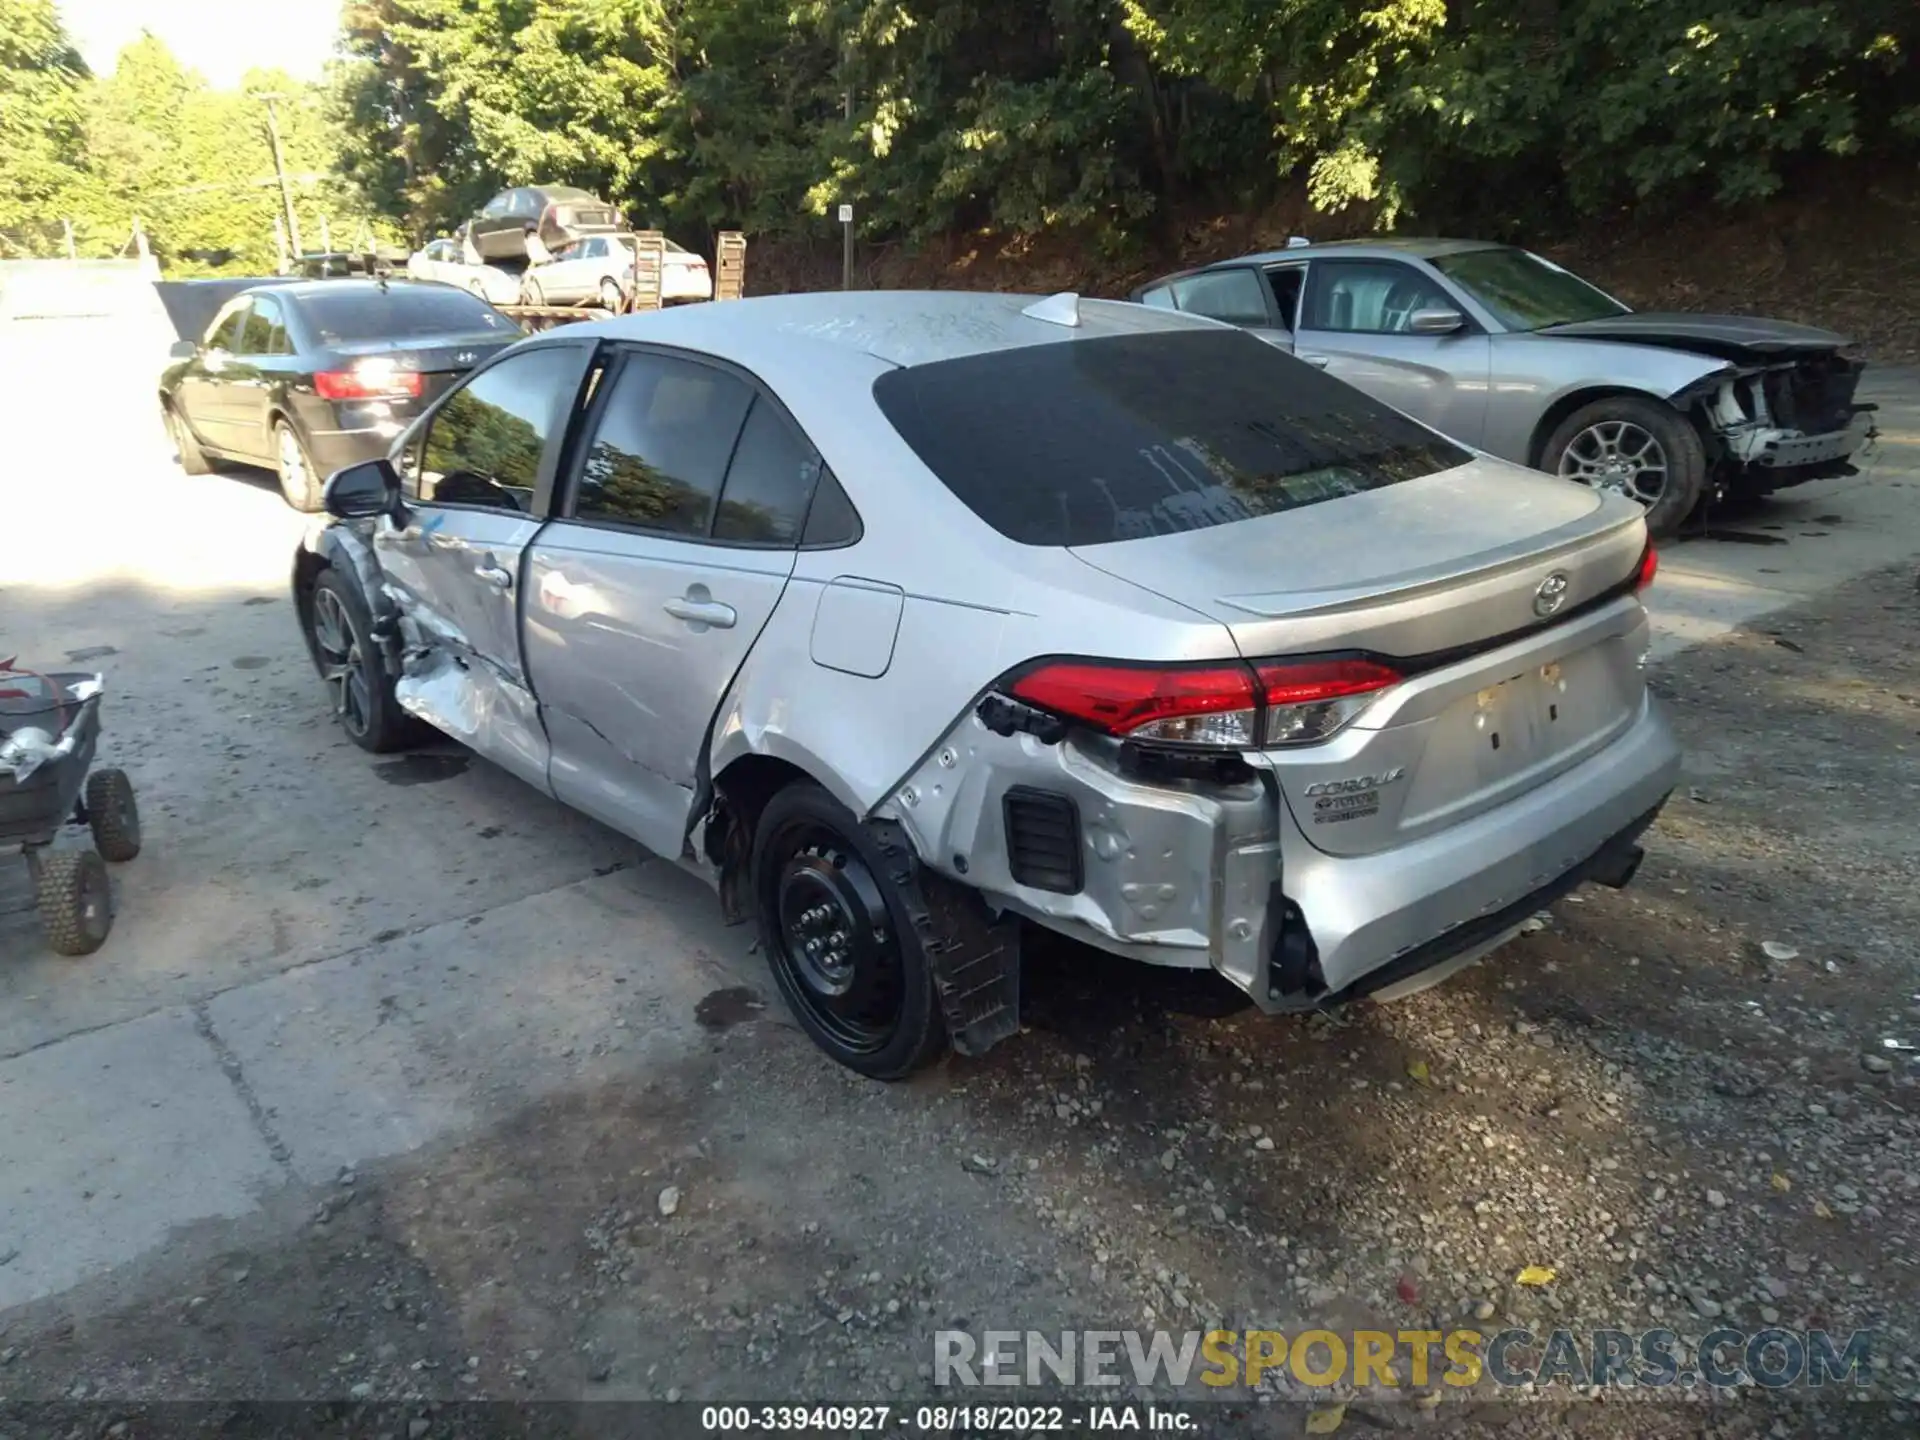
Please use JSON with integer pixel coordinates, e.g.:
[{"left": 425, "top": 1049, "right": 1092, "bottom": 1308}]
[{"left": 874, "top": 330, "right": 1473, "bottom": 545}]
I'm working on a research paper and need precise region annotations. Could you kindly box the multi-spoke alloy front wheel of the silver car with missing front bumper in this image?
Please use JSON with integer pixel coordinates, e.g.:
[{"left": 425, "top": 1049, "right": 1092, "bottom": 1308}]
[{"left": 1540, "top": 396, "right": 1707, "bottom": 540}]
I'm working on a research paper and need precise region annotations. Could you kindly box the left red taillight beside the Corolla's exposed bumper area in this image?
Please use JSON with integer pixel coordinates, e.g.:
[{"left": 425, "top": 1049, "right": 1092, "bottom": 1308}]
[{"left": 1008, "top": 660, "right": 1400, "bottom": 749}]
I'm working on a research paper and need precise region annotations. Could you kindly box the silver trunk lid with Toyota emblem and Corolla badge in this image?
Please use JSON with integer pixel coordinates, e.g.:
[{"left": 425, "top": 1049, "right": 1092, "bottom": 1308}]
[{"left": 1073, "top": 459, "right": 1645, "bottom": 854}]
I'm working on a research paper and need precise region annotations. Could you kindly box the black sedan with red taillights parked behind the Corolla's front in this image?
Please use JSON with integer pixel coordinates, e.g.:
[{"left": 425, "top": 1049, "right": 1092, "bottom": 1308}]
[{"left": 159, "top": 280, "right": 522, "bottom": 511}]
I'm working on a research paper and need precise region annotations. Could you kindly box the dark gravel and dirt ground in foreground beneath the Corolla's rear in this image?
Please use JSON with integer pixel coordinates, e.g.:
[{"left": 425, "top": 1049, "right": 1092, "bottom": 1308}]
[{"left": 0, "top": 572, "right": 1920, "bottom": 1440}]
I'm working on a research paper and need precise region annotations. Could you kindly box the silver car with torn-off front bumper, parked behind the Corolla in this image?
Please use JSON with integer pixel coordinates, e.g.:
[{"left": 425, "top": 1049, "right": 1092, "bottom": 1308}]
[{"left": 1133, "top": 236, "right": 1874, "bottom": 538}]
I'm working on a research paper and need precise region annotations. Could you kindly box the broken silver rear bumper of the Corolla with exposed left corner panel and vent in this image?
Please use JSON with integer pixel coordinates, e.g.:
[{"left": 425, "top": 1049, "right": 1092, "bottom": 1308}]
[{"left": 887, "top": 697, "right": 1680, "bottom": 1014}]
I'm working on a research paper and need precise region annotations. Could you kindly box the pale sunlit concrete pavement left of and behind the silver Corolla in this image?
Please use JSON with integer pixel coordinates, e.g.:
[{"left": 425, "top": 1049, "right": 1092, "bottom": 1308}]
[{"left": 11, "top": 293, "right": 1920, "bottom": 1351}]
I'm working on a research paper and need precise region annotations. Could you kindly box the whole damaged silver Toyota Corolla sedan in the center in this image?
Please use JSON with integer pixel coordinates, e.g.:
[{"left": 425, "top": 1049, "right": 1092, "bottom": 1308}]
[{"left": 294, "top": 292, "right": 1680, "bottom": 1077}]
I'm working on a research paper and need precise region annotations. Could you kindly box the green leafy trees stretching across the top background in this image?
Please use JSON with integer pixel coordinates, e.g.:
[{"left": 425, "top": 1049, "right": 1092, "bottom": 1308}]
[{"left": 0, "top": 0, "right": 1920, "bottom": 346}]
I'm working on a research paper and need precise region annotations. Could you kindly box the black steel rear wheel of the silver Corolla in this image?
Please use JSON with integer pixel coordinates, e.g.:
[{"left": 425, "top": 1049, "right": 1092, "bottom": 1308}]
[{"left": 751, "top": 781, "right": 947, "bottom": 1079}]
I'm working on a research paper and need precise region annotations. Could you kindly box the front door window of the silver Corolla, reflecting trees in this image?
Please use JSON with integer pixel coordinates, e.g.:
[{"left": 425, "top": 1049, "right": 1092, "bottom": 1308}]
[{"left": 409, "top": 346, "right": 580, "bottom": 511}]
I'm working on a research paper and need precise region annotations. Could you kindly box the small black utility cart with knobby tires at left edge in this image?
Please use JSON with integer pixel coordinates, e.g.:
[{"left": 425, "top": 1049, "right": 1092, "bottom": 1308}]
[{"left": 0, "top": 664, "right": 140, "bottom": 954}]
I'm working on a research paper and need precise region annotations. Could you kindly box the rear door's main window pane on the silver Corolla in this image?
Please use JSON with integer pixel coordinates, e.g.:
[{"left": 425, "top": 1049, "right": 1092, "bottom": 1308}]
[{"left": 572, "top": 353, "right": 753, "bottom": 540}]
